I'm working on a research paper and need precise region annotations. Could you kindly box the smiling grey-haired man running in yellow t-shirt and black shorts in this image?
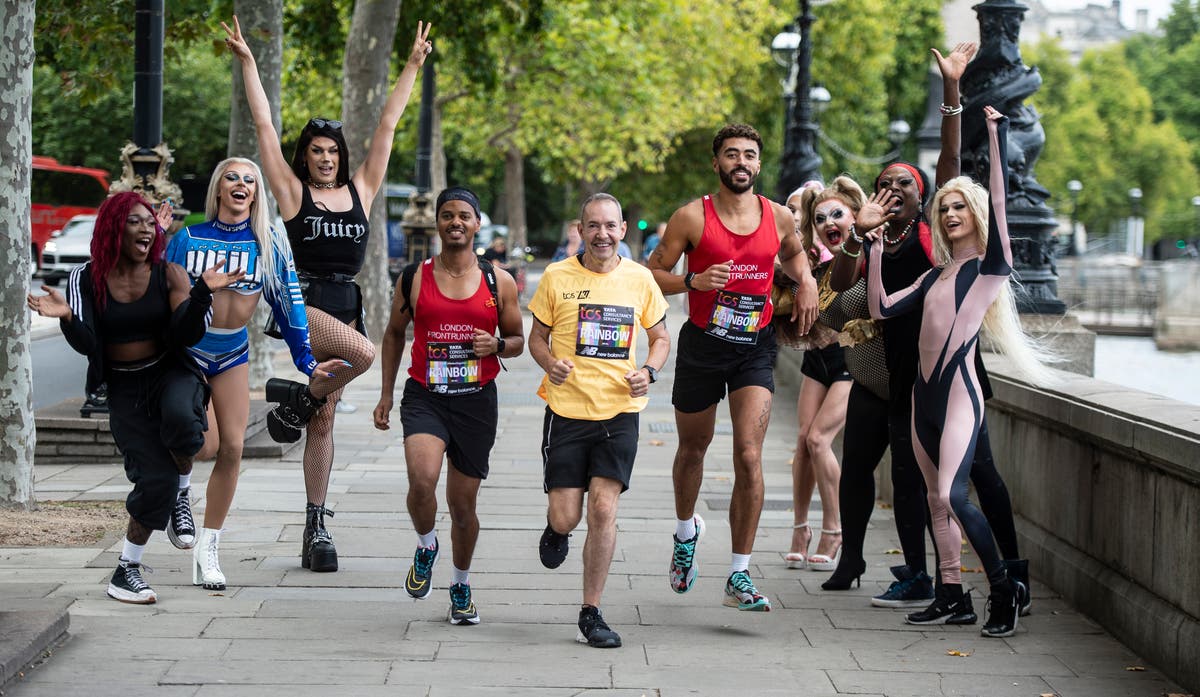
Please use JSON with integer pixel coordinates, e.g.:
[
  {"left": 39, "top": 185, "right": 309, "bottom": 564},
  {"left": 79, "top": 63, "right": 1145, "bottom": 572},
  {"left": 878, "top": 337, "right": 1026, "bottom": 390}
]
[{"left": 528, "top": 193, "right": 671, "bottom": 649}]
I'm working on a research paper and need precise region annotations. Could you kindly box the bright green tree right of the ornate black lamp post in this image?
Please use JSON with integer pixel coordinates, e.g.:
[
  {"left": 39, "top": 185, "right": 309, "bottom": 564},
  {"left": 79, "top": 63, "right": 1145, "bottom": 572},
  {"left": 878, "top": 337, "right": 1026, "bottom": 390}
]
[{"left": 1022, "top": 41, "right": 1200, "bottom": 242}]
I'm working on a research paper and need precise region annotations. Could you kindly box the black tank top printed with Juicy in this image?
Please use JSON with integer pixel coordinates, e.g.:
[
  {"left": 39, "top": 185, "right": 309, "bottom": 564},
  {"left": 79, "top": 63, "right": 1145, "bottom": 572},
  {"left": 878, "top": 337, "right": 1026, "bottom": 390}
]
[{"left": 283, "top": 184, "right": 371, "bottom": 276}]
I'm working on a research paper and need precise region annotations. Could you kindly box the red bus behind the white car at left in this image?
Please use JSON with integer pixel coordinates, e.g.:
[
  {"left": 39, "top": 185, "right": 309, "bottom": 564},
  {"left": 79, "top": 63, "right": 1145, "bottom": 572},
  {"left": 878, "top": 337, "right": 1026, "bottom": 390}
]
[{"left": 29, "top": 155, "right": 108, "bottom": 268}]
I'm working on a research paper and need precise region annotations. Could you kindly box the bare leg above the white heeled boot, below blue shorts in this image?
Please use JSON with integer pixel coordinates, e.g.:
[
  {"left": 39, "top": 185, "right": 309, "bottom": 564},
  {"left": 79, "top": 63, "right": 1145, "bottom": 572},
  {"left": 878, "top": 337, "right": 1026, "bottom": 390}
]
[{"left": 200, "top": 363, "right": 250, "bottom": 530}]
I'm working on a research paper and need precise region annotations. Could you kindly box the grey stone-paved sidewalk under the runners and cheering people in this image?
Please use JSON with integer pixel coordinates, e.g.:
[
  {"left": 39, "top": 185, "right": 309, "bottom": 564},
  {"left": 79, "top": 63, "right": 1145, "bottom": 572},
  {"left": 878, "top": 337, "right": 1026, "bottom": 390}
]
[{"left": 0, "top": 304, "right": 1181, "bottom": 697}]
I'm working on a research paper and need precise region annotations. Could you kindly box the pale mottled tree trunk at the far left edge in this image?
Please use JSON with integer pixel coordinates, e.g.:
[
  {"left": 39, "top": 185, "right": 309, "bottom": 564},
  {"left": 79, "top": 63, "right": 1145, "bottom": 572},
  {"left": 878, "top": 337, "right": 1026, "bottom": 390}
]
[{"left": 0, "top": 0, "right": 37, "bottom": 510}]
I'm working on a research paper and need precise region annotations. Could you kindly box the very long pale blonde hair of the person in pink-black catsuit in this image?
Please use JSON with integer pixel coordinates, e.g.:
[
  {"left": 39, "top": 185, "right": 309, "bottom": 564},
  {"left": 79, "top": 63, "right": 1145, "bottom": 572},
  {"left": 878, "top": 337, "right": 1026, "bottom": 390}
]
[{"left": 930, "top": 176, "right": 1063, "bottom": 384}]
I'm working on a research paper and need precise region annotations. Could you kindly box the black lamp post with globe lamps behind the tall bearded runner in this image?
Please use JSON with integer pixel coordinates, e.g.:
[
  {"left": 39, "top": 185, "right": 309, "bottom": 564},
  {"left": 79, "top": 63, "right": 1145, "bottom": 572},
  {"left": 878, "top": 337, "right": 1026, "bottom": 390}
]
[{"left": 772, "top": 0, "right": 821, "bottom": 200}]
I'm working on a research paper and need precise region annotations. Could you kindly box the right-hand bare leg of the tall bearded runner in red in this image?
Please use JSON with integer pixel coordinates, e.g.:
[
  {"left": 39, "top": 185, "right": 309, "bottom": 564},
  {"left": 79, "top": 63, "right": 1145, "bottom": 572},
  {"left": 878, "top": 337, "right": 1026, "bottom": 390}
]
[{"left": 730, "top": 385, "right": 772, "bottom": 554}]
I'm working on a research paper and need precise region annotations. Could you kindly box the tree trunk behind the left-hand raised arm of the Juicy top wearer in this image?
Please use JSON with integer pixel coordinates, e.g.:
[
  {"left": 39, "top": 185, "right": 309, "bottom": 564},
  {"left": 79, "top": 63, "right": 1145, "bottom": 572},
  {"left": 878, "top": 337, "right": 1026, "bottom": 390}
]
[{"left": 227, "top": 0, "right": 283, "bottom": 390}]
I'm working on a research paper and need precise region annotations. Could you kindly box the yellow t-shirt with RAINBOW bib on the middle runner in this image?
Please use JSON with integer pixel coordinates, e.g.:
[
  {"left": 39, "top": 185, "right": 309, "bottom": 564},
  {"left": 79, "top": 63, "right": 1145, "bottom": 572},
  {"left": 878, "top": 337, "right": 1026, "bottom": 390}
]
[{"left": 529, "top": 257, "right": 667, "bottom": 421}]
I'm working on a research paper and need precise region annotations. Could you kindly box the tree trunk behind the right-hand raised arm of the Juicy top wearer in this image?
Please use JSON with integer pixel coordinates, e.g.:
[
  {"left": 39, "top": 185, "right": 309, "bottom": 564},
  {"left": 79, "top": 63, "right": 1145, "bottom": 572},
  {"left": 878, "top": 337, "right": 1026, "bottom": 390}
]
[{"left": 342, "top": 0, "right": 408, "bottom": 341}]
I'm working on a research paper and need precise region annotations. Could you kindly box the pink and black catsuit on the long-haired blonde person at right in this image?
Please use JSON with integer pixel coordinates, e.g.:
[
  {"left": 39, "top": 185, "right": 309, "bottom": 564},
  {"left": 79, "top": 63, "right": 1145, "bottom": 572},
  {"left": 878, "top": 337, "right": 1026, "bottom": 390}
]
[{"left": 868, "top": 115, "right": 1013, "bottom": 584}]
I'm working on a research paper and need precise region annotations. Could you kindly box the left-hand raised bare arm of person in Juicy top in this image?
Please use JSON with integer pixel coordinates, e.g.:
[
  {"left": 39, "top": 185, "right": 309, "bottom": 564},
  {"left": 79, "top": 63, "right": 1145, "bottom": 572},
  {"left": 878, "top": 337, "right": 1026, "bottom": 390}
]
[{"left": 221, "top": 16, "right": 304, "bottom": 221}]
